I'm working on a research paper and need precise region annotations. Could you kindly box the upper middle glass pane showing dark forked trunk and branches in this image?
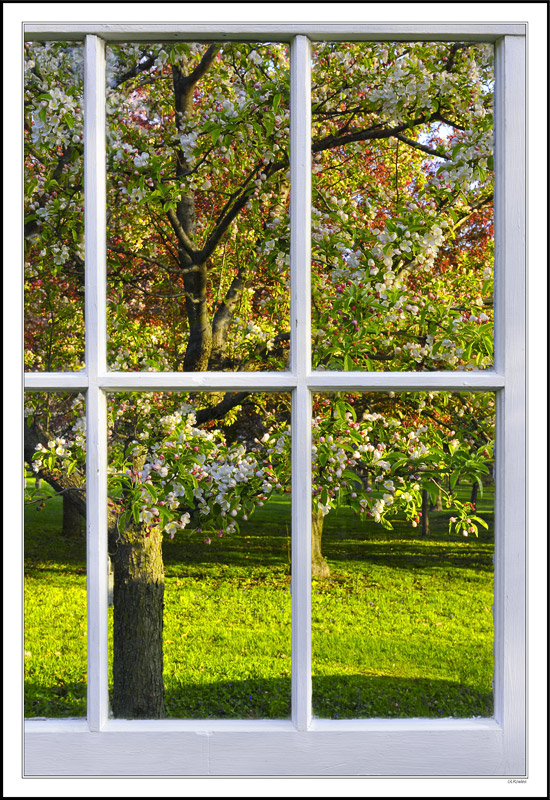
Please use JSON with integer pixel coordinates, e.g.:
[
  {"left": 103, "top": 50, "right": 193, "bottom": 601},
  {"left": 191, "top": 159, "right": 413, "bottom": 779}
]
[{"left": 107, "top": 42, "right": 290, "bottom": 372}]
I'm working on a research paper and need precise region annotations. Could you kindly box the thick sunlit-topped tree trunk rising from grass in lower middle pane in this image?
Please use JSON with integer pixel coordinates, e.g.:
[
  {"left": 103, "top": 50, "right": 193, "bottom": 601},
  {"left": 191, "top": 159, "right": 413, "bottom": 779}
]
[{"left": 112, "top": 526, "right": 165, "bottom": 719}]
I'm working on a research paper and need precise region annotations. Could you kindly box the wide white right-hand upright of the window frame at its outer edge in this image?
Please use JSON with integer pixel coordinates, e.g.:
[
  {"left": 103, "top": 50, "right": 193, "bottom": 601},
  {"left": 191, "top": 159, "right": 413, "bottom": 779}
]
[{"left": 494, "top": 37, "right": 526, "bottom": 772}]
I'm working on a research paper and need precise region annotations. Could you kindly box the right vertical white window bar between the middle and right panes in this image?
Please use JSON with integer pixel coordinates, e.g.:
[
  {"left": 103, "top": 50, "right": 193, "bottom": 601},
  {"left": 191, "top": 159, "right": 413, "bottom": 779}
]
[{"left": 290, "top": 36, "right": 311, "bottom": 730}]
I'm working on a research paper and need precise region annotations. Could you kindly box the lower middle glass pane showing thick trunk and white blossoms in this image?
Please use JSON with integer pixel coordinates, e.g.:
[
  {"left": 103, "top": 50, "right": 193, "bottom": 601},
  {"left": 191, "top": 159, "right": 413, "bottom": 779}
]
[{"left": 109, "top": 393, "right": 291, "bottom": 719}]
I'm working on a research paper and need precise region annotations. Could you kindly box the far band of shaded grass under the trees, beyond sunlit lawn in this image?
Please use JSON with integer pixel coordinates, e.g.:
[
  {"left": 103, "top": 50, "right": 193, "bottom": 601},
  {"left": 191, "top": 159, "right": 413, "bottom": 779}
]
[{"left": 25, "top": 490, "right": 493, "bottom": 575}]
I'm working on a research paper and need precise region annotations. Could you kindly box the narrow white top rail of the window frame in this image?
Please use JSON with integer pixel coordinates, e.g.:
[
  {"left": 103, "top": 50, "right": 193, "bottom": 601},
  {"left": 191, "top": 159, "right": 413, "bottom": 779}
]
[{"left": 25, "top": 21, "right": 526, "bottom": 42}]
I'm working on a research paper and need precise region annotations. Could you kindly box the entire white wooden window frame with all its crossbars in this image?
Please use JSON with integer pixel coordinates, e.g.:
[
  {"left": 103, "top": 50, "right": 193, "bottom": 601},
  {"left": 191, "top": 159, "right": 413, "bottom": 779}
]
[{"left": 24, "top": 23, "right": 526, "bottom": 776}]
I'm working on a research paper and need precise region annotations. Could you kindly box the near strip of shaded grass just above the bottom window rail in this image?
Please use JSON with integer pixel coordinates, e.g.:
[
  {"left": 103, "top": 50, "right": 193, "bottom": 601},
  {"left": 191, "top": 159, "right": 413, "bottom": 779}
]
[{"left": 25, "top": 675, "right": 493, "bottom": 719}]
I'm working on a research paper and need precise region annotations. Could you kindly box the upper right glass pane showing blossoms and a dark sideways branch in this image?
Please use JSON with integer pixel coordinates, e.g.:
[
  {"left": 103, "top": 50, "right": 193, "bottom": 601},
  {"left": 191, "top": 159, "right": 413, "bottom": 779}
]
[{"left": 312, "top": 42, "right": 494, "bottom": 371}]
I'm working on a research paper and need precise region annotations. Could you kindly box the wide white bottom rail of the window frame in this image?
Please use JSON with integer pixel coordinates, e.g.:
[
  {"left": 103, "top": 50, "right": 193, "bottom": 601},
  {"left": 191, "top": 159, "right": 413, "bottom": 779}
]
[{"left": 25, "top": 720, "right": 507, "bottom": 776}]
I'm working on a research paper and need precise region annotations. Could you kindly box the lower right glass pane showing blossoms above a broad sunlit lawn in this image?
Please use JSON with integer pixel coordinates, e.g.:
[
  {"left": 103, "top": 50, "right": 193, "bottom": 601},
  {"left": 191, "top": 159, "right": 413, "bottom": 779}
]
[{"left": 312, "top": 392, "right": 495, "bottom": 719}]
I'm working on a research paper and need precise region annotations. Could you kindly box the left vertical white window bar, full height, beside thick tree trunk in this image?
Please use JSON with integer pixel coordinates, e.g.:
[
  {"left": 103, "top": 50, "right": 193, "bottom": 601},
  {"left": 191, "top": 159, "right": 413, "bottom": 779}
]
[{"left": 84, "top": 36, "right": 109, "bottom": 731}]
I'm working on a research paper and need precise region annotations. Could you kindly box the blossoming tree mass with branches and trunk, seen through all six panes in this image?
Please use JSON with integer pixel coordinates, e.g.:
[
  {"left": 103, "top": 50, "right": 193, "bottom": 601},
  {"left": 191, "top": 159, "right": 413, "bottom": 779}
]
[{"left": 25, "top": 37, "right": 493, "bottom": 717}]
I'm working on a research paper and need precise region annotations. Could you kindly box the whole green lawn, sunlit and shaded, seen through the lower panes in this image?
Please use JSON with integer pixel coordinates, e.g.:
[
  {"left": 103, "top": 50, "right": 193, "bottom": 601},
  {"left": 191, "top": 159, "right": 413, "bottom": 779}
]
[{"left": 25, "top": 484, "right": 493, "bottom": 718}]
